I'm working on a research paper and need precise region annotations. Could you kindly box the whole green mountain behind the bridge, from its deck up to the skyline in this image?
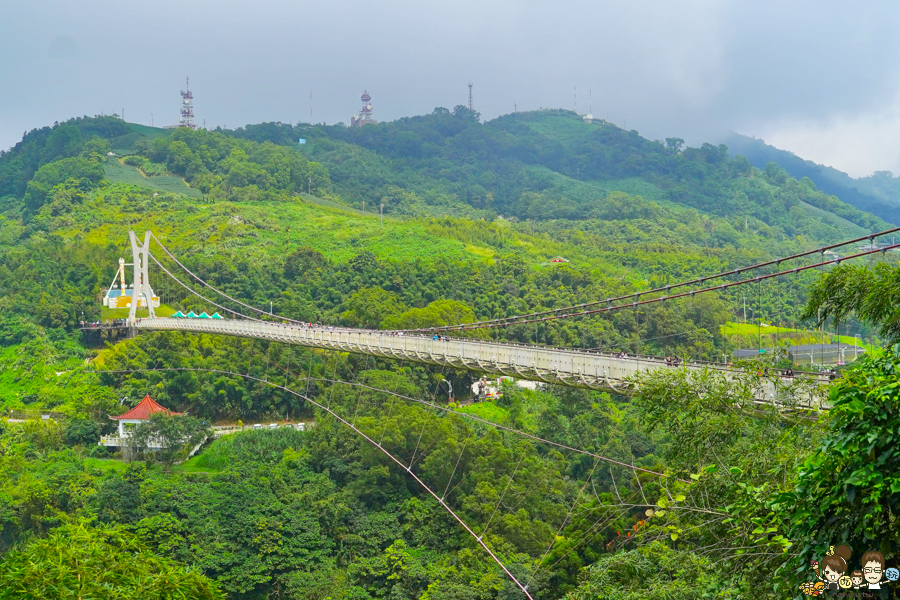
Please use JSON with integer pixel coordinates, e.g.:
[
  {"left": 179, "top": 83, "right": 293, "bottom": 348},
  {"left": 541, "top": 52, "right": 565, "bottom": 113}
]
[{"left": 0, "top": 107, "right": 888, "bottom": 372}]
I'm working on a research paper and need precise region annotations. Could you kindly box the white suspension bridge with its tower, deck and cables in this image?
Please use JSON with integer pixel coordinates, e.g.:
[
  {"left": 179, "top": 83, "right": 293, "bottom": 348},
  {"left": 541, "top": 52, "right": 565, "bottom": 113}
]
[{"left": 84, "top": 228, "right": 900, "bottom": 600}]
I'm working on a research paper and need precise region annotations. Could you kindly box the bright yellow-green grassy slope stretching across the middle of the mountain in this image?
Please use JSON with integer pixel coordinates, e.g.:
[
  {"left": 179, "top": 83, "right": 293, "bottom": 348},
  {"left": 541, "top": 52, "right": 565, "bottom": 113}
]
[{"left": 55, "top": 183, "right": 794, "bottom": 300}]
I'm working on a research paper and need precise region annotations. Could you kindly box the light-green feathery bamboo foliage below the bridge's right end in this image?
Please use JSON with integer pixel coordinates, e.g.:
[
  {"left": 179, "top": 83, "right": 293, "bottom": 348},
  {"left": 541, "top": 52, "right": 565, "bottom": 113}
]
[{"left": 632, "top": 369, "right": 820, "bottom": 598}]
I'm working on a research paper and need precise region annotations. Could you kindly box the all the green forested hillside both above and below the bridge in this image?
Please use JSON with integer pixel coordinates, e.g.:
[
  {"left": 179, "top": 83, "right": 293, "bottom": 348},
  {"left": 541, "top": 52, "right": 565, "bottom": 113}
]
[{"left": 0, "top": 113, "right": 888, "bottom": 600}]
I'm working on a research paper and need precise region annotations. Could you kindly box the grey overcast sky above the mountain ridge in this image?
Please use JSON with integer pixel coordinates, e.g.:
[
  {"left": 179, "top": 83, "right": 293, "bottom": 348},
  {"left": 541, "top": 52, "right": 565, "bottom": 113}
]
[{"left": 0, "top": 0, "right": 900, "bottom": 176}]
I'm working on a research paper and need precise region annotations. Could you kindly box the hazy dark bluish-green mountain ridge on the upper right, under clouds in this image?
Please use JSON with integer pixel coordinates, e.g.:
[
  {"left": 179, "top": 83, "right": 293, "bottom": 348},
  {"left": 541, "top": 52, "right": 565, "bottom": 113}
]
[{"left": 221, "top": 107, "right": 879, "bottom": 236}]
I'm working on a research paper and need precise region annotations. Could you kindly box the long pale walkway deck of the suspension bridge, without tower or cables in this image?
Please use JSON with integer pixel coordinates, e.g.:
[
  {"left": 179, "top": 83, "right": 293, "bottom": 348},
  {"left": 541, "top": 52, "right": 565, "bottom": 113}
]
[{"left": 135, "top": 318, "right": 826, "bottom": 408}]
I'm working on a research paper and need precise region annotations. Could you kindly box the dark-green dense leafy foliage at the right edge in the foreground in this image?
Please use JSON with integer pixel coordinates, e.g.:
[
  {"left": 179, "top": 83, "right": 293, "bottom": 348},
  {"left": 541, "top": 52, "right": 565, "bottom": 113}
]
[{"left": 774, "top": 344, "right": 900, "bottom": 574}]
